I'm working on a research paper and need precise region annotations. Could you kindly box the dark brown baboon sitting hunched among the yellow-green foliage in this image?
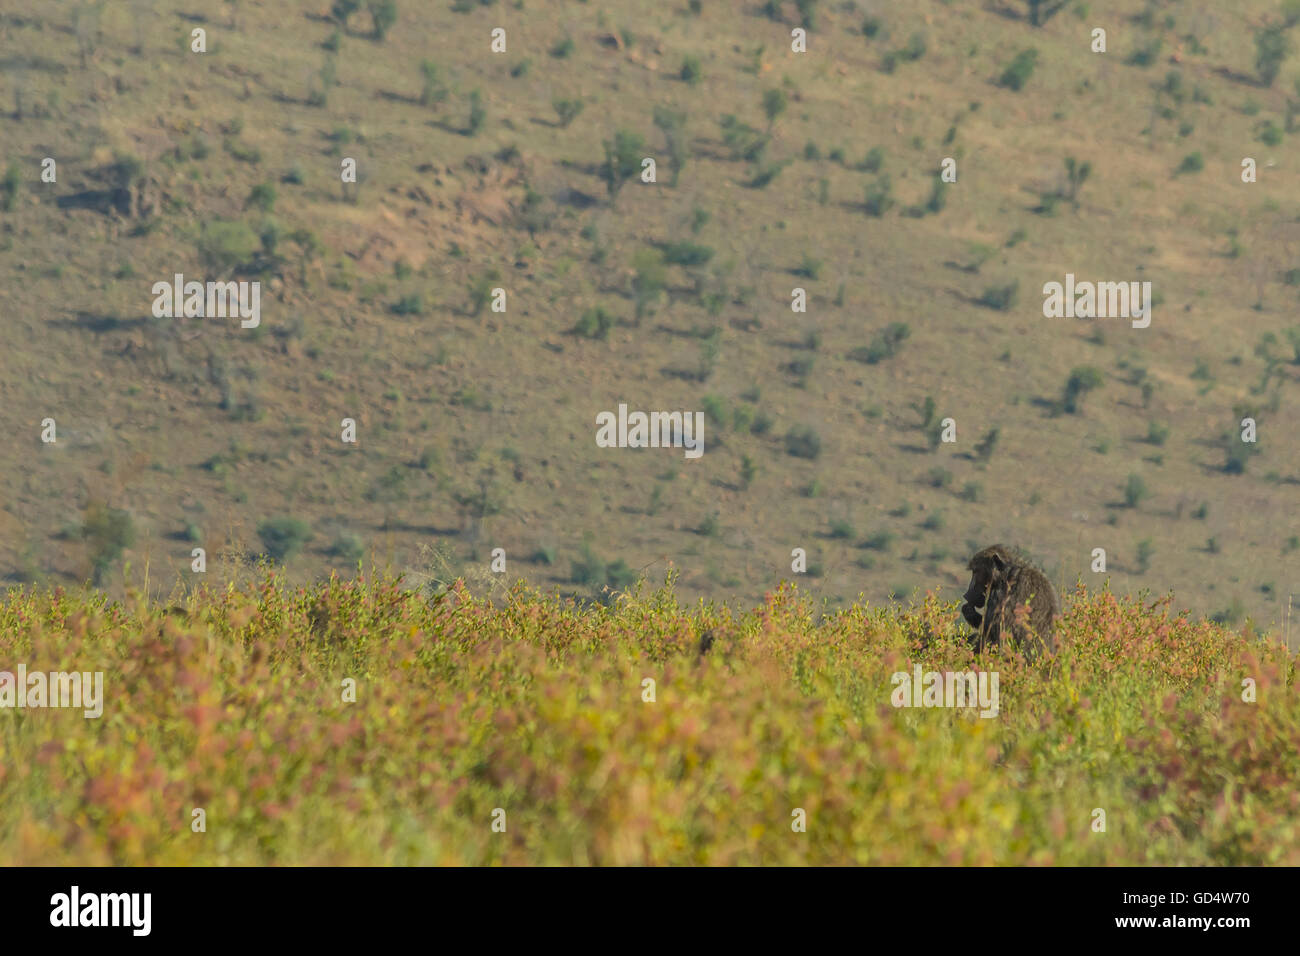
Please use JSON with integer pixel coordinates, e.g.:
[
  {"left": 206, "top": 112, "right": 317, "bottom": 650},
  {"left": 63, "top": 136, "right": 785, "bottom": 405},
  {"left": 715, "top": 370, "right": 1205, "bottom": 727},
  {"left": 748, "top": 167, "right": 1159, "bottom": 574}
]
[{"left": 962, "top": 545, "right": 1061, "bottom": 661}]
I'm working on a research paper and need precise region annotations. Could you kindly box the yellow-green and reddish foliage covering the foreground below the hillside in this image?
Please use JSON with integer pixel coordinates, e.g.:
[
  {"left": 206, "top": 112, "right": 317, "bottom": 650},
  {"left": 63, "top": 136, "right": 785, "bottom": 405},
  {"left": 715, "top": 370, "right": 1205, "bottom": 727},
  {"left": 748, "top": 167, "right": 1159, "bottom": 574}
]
[{"left": 0, "top": 576, "right": 1300, "bottom": 865}]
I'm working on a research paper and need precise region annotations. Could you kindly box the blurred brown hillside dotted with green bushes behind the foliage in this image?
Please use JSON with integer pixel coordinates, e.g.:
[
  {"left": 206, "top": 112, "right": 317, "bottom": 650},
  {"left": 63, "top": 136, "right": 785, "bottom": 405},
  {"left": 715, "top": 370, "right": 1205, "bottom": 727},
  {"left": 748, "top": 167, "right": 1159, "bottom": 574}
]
[{"left": 0, "top": 0, "right": 1300, "bottom": 634}]
